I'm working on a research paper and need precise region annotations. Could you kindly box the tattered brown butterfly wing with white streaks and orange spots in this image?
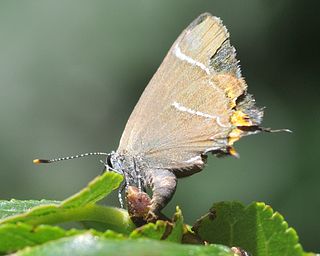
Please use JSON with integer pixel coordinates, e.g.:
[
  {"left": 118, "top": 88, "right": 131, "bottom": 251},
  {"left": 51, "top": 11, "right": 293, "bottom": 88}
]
[{"left": 117, "top": 14, "right": 261, "bottom": 175}]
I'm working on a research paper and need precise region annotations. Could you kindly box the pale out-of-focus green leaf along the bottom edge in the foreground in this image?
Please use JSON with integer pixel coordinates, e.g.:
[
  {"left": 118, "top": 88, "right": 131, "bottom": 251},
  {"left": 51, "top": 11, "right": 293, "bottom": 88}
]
[{"left": 15, "top": 232, "right": 234, "bottom": 256}]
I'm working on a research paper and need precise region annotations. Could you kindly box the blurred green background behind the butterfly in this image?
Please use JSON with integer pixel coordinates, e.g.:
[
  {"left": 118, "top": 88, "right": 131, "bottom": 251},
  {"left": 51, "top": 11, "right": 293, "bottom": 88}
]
[{"left": 0, "top": 0, "right": 320, "bottom": 251}]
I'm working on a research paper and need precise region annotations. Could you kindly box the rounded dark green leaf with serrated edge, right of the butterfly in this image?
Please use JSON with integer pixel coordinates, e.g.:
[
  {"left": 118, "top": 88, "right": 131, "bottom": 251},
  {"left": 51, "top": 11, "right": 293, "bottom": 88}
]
[{"left": 193, "top": 202, "right": 304, "bottom": 256}]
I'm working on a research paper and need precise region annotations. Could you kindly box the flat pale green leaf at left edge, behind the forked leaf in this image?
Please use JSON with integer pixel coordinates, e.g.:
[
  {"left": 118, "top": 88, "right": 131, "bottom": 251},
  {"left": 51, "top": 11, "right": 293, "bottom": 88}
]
[{"left": 0, "top": 199, "right": 60, "bottom": 219}]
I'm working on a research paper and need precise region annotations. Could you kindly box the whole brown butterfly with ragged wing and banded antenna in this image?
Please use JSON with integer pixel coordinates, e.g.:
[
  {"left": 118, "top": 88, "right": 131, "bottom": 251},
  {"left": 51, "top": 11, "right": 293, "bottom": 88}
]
[{"left": 34, "top": 13, "right": 282, "bottom": 220}]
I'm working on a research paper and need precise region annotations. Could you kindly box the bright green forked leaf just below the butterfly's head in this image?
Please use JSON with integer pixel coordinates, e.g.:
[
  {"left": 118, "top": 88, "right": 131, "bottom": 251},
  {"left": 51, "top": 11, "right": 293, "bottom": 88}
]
[{"left": 0, "top": 172, "right": 135, "bottom": 234}]
